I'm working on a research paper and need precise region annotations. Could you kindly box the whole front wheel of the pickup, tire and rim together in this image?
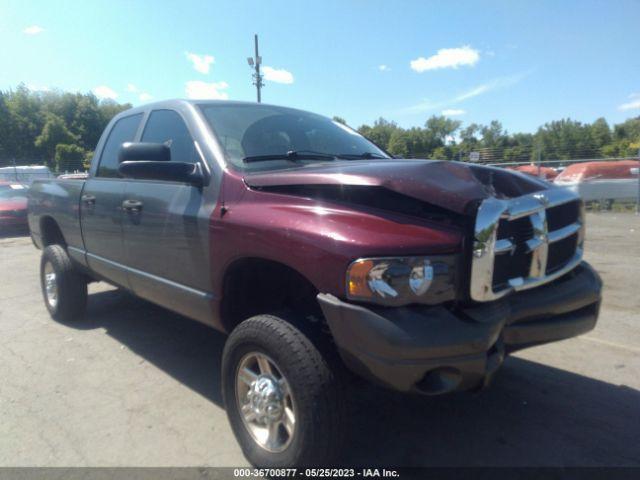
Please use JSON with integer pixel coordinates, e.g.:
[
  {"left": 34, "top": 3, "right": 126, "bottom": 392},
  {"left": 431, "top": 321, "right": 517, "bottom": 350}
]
[{"left": 222, "top": 315, "right": 345, "bottom": 467}]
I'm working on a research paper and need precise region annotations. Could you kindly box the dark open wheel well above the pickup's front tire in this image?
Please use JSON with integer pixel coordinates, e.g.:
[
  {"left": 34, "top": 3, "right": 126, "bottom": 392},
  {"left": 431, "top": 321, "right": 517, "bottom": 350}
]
[{"left": 221, "top": 258, "right": 323, "bottom": 332}]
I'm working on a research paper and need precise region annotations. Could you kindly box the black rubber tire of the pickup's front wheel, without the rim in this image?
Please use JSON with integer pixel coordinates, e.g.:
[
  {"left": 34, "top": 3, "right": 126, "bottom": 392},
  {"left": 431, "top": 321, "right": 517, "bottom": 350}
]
[{"left": 222, "top": 315, "right": 347, "bottom": 467}]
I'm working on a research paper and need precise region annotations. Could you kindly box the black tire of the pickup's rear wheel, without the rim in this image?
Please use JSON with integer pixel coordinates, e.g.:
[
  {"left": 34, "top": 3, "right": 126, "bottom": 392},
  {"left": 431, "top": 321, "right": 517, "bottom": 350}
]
[{"left": 40, "top": 245, "right": 87, "bottom": 323}]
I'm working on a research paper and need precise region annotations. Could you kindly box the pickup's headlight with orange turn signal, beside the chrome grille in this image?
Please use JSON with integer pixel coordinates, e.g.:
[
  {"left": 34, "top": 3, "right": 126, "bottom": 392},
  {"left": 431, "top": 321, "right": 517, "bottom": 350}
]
[{"left": 347, "top": 255, "right": 457, "bottom": 306}]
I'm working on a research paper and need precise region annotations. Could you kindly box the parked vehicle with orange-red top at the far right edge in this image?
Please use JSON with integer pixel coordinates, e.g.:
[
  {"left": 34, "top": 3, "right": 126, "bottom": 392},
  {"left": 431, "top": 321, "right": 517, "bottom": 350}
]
[{"left": 554, "top": 160, "right": 640, "bottom": 204}]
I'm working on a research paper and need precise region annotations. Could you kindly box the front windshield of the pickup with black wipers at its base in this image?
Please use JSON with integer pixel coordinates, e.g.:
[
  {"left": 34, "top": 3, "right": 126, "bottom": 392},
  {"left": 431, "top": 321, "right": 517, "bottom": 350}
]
[{"left": 200, "top": 104, "right": 389, "bottom": 170}]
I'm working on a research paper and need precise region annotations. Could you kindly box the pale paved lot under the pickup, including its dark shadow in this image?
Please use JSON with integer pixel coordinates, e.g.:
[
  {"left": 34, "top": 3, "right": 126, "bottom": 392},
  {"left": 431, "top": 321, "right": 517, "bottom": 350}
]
[{"left": 0, "top": 213, "right": 640, "bottom": 466}]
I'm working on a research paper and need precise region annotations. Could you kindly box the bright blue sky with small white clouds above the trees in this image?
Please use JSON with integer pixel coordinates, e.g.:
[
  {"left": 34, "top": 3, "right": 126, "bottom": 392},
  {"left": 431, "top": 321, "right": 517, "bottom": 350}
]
[{"left": 0, "top": 0, "right": 640, "bottom": 131}]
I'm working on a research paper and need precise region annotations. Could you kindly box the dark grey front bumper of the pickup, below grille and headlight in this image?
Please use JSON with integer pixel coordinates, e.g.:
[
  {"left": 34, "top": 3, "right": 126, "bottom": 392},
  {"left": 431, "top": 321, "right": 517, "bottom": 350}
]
[{"left": 318, "top": 262, "right": 602, "bottom": 395}]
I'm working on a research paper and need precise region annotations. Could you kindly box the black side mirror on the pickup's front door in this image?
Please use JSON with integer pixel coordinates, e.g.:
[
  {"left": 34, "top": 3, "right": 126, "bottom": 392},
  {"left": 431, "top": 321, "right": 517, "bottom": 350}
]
[{"left": 118, "top": 160, "right": 204, "bottom": 187}]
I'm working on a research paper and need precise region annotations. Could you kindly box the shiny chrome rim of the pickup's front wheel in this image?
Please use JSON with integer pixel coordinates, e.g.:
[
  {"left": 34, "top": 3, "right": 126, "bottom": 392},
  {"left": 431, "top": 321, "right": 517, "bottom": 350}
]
[{"left": 236, "top": 352, "right": 296, "bottom": 453}]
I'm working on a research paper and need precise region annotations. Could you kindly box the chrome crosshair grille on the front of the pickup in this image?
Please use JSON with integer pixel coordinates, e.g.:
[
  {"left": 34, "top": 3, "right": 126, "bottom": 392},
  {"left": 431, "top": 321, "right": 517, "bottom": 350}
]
[{"left": 471, "top": 187, "right": 584, "bottom": 302}]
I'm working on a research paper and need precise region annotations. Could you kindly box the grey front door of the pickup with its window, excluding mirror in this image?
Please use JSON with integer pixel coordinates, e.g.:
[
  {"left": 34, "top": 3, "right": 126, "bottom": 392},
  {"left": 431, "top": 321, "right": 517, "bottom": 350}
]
[{"left": 122, "top": 109, "right": 211, "bottom": 318}]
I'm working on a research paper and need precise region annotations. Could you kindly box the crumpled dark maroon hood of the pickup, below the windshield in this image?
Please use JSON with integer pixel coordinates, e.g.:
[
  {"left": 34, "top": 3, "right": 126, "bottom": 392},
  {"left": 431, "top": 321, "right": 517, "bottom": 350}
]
[{"left": 244, "top": 159, "right": 551, "bottom": 214}]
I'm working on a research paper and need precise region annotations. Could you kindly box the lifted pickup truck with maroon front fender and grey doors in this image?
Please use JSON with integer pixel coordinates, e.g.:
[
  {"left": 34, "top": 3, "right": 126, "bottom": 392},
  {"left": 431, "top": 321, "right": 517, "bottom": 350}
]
[{"left": 29, "top": 100, "right": 601, "bottom": 466}]
